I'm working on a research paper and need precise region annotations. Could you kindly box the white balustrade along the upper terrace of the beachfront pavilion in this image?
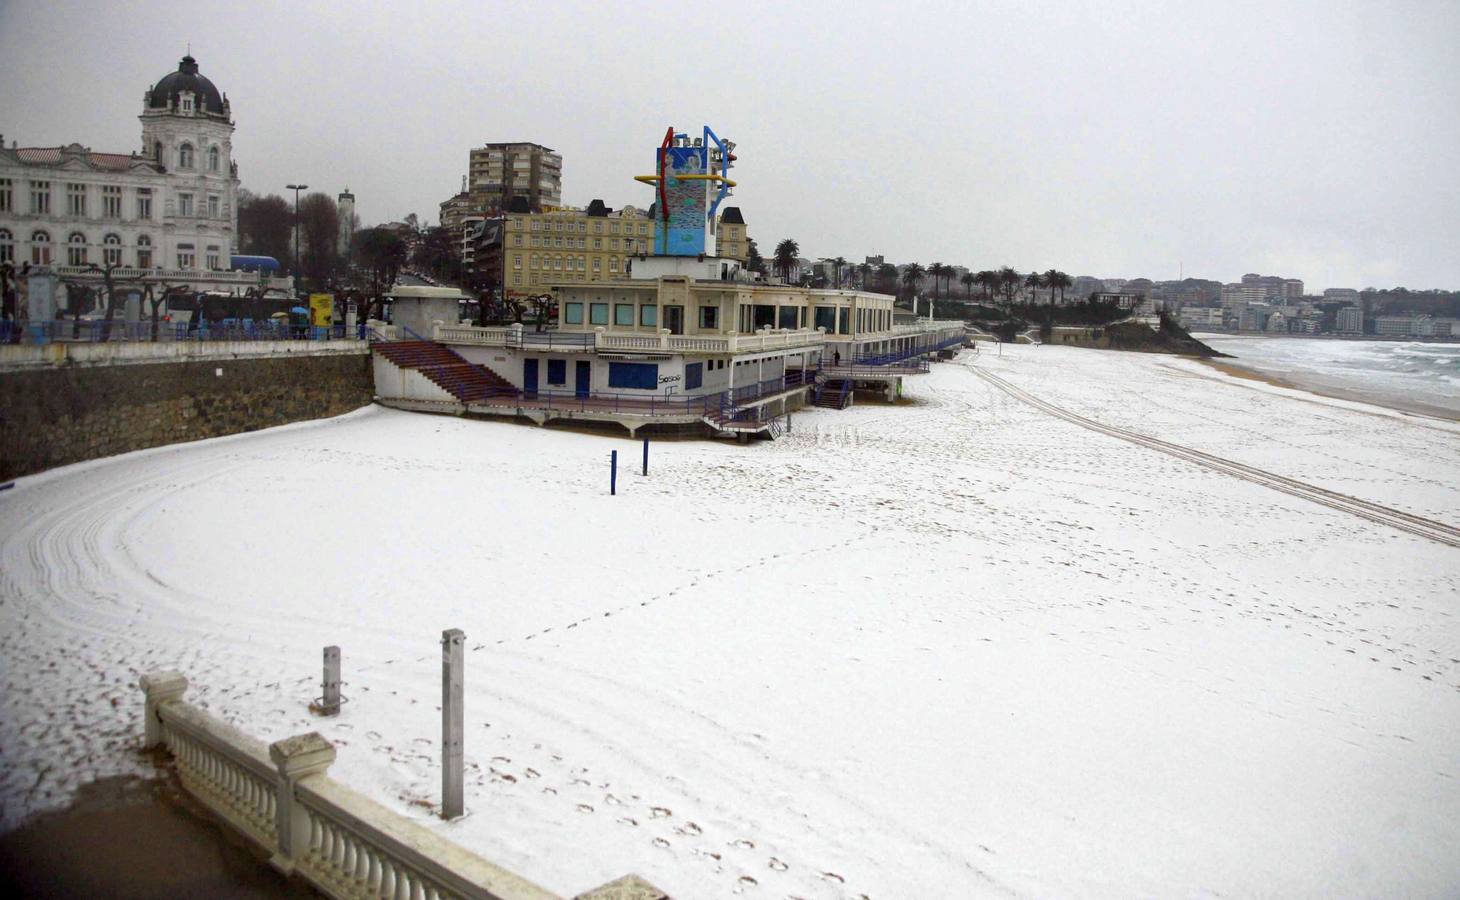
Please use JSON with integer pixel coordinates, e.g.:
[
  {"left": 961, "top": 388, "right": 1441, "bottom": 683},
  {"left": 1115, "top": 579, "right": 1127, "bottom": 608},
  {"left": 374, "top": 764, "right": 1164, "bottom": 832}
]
[{"left": 431, "top": 323, "right": 826, "bottom": 354}]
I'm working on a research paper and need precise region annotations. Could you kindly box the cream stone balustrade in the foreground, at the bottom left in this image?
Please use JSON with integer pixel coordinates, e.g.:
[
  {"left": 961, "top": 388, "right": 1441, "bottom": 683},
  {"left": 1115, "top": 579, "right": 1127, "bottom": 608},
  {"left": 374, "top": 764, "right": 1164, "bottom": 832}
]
[{"left": 142, "top": 672, "right": 658, "bottom": 900}]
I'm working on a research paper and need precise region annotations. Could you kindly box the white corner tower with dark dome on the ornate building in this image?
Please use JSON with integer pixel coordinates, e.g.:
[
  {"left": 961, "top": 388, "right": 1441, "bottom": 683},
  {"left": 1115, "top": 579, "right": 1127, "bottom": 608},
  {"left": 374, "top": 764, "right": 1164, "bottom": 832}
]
[{"left": 140, "top": 56, "right": 238, "bottom": 261}]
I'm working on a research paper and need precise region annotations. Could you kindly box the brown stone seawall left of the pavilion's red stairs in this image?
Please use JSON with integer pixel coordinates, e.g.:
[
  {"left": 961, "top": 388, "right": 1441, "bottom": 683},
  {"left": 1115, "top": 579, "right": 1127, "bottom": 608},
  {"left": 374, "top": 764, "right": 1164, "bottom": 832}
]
[{"left": 0, "top": 351, "right": 375, "bottom": 482}]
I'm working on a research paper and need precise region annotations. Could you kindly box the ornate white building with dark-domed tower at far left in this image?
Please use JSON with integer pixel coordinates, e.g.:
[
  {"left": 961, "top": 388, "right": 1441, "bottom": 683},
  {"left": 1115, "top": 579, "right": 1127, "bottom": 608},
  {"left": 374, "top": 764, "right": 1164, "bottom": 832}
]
[{"left": 0, "top": 56, "right": 279, "bottom": 317}]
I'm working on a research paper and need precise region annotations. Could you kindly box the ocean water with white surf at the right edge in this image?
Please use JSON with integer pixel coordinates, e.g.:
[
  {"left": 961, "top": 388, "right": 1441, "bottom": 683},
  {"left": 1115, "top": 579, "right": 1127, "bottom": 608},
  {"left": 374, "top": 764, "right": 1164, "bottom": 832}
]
[{"left": 1197, "top": 335, "right": 1460, "bottom": 415}]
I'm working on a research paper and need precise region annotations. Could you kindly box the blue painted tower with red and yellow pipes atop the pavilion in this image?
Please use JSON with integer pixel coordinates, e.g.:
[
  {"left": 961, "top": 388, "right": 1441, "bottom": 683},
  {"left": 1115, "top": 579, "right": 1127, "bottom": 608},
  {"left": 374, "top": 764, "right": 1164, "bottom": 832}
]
[{"left": 635, "top": 126, "right": 736, "bottom": 257}]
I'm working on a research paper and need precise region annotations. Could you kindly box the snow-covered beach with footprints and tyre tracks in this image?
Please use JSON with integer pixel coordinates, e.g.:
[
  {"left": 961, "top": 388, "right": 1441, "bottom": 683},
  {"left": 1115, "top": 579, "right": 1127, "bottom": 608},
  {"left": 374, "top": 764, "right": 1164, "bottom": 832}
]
[{"left": 0, "top": 346, "right": 1460, "bottom": 897}]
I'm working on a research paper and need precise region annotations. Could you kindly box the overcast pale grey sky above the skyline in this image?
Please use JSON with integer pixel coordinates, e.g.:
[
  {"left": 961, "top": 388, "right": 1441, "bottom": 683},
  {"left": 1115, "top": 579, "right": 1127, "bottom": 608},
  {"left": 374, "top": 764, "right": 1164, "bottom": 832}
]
[{"left": 0, "top": 0, "right": 1460, "bottom": 289}]
